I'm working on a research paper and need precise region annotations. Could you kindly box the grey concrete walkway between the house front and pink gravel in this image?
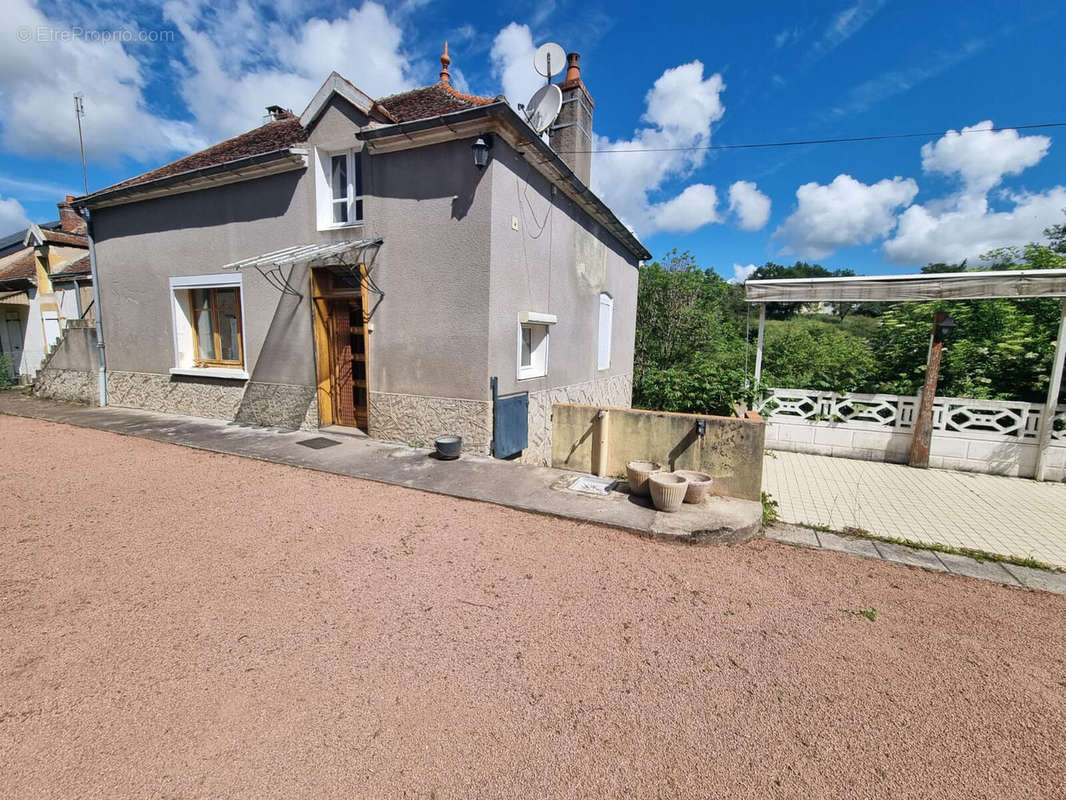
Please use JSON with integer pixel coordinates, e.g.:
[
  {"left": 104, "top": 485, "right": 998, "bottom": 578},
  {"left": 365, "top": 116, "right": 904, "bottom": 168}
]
[{"left": 0, "top": 391, "right": 762, "bottom": 542}]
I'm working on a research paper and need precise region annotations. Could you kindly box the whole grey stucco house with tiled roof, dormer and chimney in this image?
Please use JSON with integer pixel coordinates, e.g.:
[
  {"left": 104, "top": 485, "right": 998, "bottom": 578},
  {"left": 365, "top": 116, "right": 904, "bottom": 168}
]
[{"left": 66, "top": 47, "right": 649, "bottom": 463}]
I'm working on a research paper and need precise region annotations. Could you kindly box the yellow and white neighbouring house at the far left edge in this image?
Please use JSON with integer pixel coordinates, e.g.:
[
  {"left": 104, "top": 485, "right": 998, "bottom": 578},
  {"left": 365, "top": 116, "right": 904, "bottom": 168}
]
[{"left": 0, "top": 197, "right": 93, "bottom": 382}]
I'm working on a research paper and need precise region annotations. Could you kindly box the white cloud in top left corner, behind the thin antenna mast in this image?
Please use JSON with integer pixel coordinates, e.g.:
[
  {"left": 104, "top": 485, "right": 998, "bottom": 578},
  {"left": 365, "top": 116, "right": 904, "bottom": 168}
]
[{"left": 0, "top": 0, "right": 203, "bottom": 161}]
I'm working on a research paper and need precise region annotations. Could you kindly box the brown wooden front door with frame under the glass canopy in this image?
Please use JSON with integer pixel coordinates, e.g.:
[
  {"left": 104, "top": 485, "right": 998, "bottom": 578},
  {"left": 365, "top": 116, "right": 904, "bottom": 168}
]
[{"left": 311, "top": 270, "right": 370, "bottom": 431}]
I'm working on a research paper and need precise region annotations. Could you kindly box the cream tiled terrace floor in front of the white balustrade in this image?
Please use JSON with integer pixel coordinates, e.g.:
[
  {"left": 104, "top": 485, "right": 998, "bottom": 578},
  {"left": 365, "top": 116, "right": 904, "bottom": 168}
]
[{"left": 763, "top": 451, "right": 1066, "bottom": 566}]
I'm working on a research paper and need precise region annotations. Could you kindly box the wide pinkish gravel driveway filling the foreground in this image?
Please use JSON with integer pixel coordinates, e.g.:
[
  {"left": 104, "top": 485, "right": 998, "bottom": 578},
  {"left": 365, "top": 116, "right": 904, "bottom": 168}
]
[{"left": 0, "top": 416, "right": 1066, "bottom": 800}]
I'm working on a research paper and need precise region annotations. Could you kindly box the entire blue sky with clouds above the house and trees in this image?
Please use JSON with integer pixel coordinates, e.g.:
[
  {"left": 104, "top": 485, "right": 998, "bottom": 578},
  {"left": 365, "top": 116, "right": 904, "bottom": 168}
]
[{"left": 0, "top": 0, "right": 1066, "bottom": 277}]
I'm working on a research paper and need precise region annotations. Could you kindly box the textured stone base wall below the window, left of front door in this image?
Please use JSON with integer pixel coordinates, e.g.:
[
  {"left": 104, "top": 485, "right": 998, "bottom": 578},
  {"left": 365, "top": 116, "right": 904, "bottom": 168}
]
[{"left": 108, "top": 371, "right": 318, "bottom": 430}]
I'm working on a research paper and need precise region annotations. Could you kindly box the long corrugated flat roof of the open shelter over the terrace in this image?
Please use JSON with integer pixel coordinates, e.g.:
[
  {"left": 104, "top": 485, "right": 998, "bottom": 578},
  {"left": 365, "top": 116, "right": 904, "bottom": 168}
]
[{"left": 744, "top": 270, "right": 1066, "bottom": 303}]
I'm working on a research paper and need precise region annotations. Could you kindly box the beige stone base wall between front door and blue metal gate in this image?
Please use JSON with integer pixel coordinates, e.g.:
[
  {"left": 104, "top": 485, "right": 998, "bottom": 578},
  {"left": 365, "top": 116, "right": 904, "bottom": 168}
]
[{"left": 369, "top": 391, "right": 492, "bottom": 455}]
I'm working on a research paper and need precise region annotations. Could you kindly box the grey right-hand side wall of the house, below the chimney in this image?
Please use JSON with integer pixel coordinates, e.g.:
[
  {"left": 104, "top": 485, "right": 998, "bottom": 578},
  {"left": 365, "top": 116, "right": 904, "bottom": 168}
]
[{"left": 488, "top": 141, "right": 639, "bottom": 464}]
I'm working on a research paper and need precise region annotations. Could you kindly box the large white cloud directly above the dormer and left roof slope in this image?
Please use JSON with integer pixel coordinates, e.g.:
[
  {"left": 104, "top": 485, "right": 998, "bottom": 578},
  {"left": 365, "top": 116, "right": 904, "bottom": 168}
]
[{"left": 163, "top": 0, "right": 415, "bottom": 140}]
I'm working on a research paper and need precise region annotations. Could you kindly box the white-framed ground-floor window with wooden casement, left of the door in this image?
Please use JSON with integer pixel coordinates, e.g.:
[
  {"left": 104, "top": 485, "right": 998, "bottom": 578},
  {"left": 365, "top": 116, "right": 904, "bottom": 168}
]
[{"left": 171, "top": 273, "right": 248, "bottom": 380}]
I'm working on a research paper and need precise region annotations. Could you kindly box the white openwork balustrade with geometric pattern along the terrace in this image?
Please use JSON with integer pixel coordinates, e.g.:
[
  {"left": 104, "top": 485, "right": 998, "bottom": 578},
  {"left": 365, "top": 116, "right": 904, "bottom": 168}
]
[{"left": 756, "top": 389, "right": 1066, "bottom": 442}]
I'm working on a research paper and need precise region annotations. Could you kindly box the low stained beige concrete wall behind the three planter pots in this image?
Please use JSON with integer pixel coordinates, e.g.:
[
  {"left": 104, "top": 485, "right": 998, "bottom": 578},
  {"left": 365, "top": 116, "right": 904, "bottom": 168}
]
[{"left": 551, "top": 403, "right": 765, "bottom": 500}]
